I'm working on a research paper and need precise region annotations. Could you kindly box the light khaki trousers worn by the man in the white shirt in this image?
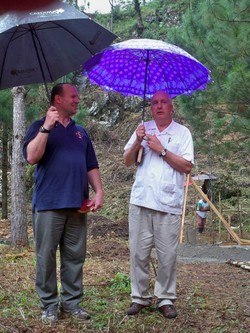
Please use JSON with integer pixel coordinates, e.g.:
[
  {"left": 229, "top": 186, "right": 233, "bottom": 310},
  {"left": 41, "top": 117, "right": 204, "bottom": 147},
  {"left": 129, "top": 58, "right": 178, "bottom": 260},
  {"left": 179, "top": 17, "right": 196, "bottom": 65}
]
[{"left": 129, "top": 205, "right": 181, "bottom": 306}]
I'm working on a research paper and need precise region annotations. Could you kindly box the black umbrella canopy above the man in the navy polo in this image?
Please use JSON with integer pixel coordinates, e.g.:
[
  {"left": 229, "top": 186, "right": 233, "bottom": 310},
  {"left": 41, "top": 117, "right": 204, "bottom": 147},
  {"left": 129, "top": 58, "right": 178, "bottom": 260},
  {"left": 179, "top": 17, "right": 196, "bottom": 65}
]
[{"left": 0, "top": 2, "right": 116, "bottom": 93}]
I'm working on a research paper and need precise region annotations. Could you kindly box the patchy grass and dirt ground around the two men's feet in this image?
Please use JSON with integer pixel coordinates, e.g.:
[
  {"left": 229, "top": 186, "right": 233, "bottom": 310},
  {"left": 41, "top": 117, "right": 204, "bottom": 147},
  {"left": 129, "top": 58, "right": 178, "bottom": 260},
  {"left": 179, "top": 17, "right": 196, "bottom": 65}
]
[{"left": 0, "top": 237, "right": 250, "bottom": 333}]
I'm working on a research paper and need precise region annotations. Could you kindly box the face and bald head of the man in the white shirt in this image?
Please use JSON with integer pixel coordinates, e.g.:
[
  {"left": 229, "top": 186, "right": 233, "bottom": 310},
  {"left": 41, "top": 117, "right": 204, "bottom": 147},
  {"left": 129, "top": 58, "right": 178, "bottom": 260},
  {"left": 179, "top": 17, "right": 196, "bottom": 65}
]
[{"left": 151, "top": 91, "right": 173, "bottom": 122}]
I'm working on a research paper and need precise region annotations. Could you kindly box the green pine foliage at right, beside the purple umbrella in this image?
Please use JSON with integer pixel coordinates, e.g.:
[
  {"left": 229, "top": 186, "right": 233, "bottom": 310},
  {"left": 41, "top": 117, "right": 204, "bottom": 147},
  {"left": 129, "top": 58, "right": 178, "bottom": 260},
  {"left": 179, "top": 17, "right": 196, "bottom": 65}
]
[{"left": 165, "top": 0, "right": 250, "bottom": 163}]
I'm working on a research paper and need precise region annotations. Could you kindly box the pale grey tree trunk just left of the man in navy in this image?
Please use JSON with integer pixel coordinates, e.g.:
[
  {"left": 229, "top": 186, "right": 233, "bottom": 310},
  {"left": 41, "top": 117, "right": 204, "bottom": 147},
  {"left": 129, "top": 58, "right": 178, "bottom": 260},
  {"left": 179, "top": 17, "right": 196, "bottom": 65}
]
[{"left": 11, "top": 87, "right": 28, "bottom": 246}]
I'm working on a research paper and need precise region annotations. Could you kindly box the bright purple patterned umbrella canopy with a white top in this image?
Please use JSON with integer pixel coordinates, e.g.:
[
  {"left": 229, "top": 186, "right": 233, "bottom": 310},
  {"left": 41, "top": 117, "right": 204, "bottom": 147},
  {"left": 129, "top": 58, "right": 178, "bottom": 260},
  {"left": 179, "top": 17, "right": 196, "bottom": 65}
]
[{"left": 83, "top": 39, "right": 212, "bottom": 109}]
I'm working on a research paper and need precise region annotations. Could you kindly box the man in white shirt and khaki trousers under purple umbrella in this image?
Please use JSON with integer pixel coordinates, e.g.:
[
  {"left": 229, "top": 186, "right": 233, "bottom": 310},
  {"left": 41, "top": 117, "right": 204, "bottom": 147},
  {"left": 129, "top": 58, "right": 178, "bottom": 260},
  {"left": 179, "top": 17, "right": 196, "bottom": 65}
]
[{"left": 124, "top": 91, "right": 194, "bottom": 318}]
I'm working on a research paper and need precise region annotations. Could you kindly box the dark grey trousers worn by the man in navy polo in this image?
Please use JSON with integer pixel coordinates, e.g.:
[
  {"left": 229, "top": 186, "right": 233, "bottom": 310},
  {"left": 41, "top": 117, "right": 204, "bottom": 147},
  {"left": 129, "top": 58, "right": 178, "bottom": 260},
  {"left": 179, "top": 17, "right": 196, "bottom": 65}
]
[{"left": 33, "top": 209, "right": 87, "bottom": 309}]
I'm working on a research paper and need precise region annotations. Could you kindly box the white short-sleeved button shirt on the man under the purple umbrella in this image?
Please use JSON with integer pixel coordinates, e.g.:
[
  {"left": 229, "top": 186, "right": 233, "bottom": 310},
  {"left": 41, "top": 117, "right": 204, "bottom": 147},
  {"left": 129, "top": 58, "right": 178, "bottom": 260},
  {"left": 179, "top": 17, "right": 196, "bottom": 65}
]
[{"left": 124, "top": 120, "right": 194, "bottom": 215}]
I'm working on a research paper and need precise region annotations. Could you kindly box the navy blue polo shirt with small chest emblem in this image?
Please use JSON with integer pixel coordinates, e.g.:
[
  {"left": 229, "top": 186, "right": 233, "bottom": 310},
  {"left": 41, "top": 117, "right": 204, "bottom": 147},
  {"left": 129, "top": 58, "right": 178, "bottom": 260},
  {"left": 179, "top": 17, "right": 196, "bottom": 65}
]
[{"left": 23, "top": 118, "right": 99, "bottom": 211}]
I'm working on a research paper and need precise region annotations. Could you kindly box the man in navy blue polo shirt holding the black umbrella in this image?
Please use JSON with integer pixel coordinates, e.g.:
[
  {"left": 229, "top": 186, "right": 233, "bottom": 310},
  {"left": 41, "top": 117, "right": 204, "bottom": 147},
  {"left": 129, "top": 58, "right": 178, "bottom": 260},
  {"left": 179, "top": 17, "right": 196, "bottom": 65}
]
[{"left": 23, "top": 83, "right": 103, "bottom": 321}]
